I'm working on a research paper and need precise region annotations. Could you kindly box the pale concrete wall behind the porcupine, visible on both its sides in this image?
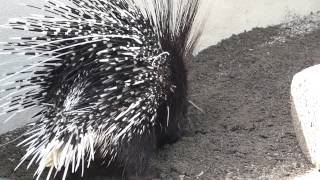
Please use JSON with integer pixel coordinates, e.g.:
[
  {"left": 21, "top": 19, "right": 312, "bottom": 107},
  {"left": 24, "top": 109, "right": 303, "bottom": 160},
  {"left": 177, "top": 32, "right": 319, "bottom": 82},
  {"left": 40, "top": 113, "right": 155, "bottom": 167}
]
[{"left": 0, "top": 0, "right": 320, "bottom": 134}]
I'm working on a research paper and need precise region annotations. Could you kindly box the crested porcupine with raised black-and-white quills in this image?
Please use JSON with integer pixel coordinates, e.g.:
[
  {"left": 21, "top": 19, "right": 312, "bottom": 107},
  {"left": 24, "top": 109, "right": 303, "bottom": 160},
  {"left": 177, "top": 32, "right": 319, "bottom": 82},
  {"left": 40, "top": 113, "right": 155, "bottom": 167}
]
[{"left": 0, "top": 0, "right": 202, "bottom": 179}]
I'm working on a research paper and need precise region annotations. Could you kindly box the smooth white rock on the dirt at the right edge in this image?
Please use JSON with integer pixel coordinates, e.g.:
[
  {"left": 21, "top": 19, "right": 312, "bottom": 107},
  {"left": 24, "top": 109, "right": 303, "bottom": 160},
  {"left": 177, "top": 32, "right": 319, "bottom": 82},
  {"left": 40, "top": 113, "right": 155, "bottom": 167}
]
[{"left": 291, "top": 65, "right": 320, "bottom": 168}]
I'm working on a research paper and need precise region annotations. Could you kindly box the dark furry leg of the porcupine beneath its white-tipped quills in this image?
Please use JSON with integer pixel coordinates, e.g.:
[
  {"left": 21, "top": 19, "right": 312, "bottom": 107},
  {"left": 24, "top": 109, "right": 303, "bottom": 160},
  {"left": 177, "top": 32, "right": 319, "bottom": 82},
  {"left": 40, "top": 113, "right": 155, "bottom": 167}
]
[{"left": 64, "top": 133, "right": 156, "bottom": 180}]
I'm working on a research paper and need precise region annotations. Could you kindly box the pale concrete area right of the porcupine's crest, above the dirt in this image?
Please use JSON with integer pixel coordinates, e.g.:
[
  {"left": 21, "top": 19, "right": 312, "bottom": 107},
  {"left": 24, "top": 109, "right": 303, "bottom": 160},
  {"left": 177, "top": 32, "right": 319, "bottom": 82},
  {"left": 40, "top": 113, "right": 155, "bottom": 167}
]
[{"left": 198, "top": 0, "right": 320, "bottom": 50}]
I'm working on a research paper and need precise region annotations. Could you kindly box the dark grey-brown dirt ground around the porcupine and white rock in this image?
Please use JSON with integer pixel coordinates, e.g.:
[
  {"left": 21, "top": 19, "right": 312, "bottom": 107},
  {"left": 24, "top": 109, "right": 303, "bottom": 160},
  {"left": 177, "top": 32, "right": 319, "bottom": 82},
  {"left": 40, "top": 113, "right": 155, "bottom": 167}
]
[{"left": 0, "top": 14, "right": 320, "bottom": 180}]
